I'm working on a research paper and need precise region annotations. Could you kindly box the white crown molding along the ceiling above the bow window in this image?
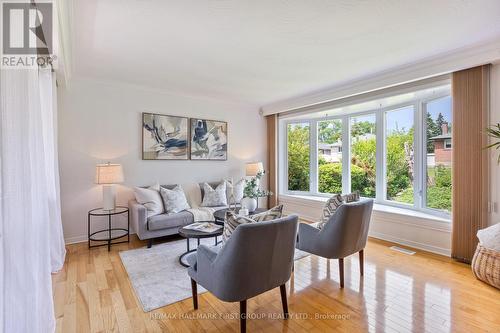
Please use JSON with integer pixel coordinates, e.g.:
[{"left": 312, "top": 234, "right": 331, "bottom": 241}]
[{"left": 261, "top": 38, "right": 500, "bottom": 116}]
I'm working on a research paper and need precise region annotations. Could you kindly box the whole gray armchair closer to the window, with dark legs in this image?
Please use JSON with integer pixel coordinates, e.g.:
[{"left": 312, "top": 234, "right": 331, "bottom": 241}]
[{"left": 297, "top": 199, "right": 373, "bottom": 288}]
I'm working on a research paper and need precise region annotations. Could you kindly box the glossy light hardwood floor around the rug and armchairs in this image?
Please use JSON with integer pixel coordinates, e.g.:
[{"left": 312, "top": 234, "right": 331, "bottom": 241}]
[{"left": 53, "top": 237, "right": 500, "bottom": 332}]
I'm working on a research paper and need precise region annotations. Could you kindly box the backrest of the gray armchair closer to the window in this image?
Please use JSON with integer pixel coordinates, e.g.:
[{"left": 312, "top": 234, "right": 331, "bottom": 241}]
[{"left": 318, "top": 199, "right": 373, "bottom": 258}]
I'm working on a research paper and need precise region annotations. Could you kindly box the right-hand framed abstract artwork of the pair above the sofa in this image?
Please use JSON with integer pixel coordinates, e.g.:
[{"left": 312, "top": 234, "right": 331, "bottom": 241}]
[{"left": 190, "top": 118, "right": 227, "bottom": 161}]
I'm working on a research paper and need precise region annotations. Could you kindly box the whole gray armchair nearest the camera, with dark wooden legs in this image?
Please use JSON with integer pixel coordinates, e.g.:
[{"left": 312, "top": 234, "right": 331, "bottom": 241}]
[{"left": 187, "top": 215, "right": 298, "bottom": 332}]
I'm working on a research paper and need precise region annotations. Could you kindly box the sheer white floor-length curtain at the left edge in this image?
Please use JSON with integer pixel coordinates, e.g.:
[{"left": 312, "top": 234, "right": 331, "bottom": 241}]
[{"left": 0, "top": 69, "right": 65, "bottom": 332}]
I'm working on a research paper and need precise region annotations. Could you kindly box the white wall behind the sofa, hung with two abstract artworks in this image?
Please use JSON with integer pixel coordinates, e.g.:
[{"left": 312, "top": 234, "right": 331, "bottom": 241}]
[{"left": 58, "top": 80, "right": 267, "bottom": 242}]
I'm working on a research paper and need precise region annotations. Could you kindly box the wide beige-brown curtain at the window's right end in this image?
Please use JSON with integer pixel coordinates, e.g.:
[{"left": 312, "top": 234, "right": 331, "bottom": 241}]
[{"left": 451, "top": 65, "right": 490, "bottom": 263}]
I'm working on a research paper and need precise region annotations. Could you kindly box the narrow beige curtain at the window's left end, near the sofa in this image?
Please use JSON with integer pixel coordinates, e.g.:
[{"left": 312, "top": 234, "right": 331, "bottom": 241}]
[{"left": 266, "top": 114, "right": 278, "bottom": 207}]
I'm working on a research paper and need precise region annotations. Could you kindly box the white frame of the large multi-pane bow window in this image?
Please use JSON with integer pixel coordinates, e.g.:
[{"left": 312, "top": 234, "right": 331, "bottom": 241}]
[{"left": 280, "top": 91, "right": 451, "bottom": 219}]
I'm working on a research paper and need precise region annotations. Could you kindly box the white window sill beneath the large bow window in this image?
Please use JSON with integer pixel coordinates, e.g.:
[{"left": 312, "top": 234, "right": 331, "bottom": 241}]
[{"left": 279, "top": 194, "right": 451, "bottom": 225}]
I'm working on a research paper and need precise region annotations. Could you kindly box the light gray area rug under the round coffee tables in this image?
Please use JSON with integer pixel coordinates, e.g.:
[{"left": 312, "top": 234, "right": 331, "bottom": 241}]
[{"left": 120, "top": 238, "right": 309, "bottom": 312}]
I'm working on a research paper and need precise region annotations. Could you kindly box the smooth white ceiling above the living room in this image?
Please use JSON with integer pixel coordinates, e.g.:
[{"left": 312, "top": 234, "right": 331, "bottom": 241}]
[{"left": 71, "top": 0, "right": 500, "bottom": 106}]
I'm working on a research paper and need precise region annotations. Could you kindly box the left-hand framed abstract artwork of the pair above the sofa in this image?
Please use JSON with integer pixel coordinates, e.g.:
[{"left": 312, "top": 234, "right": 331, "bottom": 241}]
[{"left": 142, "top": 113, "right": 189, "bottom": 160}]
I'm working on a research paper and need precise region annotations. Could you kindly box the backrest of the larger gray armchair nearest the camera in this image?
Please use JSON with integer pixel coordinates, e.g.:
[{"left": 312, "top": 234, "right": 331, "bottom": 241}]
[{"left": 211, "top": 215, "right": 298, "bottom": 302}]
